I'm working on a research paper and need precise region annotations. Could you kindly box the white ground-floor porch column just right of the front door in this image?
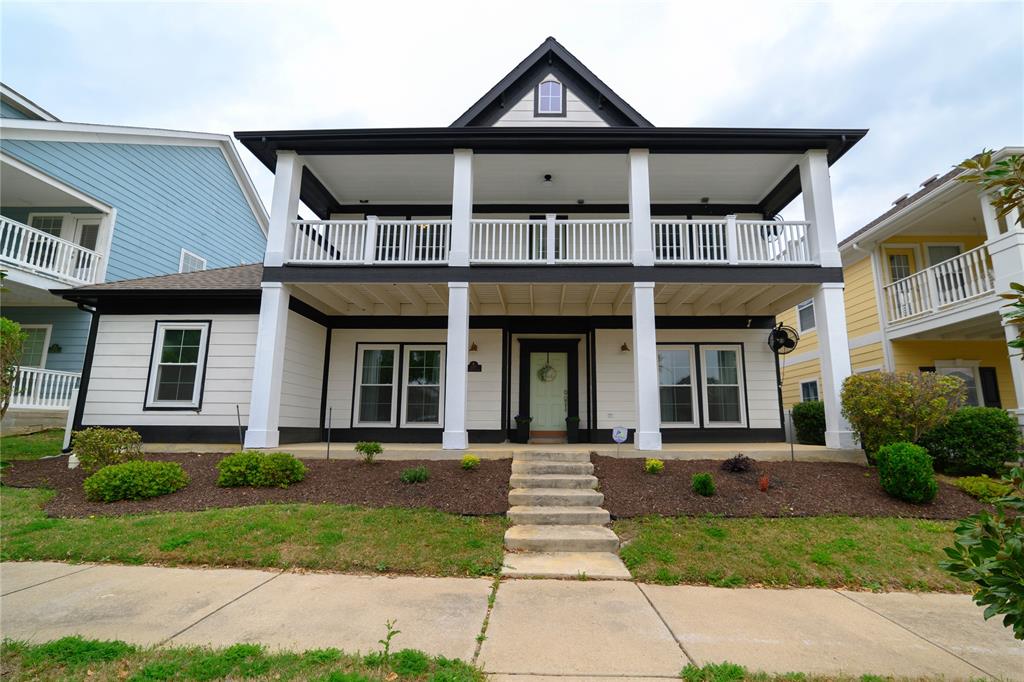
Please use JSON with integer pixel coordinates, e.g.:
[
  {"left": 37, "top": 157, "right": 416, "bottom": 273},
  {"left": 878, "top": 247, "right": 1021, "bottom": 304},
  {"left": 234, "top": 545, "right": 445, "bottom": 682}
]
[{"left": 633, "top": 282, "right": 662, "bottom": 450}]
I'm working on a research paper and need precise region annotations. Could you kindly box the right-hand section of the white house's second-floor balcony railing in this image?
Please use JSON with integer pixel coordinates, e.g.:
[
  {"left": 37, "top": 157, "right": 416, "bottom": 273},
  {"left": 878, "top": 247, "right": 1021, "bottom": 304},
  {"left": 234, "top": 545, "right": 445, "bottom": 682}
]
[{"left": 651, "top": 218, "right": 815, "bottom": 265}]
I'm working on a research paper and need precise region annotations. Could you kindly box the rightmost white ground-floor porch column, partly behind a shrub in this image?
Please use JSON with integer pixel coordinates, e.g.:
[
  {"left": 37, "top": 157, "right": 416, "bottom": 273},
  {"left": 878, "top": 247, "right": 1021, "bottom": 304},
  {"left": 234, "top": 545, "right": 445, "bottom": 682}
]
[{"left": 814, "top": 282, "right": 857, "bottom": 447}]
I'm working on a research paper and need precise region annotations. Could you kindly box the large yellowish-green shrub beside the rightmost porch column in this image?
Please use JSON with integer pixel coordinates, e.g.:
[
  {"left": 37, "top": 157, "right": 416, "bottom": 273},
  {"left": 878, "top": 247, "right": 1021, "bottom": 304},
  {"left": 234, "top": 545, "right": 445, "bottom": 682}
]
[{"left": 842, "top": 372, "right": 967, "bottom": 464}]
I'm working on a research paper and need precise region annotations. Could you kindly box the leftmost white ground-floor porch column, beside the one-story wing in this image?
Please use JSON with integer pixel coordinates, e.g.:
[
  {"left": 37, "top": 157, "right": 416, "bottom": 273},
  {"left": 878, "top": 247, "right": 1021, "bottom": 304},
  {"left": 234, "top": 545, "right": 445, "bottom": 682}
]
[{"left": 246, "top": 282, "right": 290, "bottom": 447}]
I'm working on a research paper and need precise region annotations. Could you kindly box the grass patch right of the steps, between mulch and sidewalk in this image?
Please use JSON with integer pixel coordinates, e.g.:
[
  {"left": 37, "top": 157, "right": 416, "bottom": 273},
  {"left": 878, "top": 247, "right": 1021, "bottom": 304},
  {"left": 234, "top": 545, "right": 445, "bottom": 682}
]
[{"left": 612, "top": 516, "right": 970, "bottom": 592}]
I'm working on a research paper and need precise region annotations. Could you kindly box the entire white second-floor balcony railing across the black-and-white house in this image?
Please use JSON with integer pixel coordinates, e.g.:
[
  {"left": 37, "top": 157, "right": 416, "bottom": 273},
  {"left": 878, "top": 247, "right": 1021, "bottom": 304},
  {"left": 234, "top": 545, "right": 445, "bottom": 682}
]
[{"left": 287, "top": 215, "right": 819, "bottom": 265}]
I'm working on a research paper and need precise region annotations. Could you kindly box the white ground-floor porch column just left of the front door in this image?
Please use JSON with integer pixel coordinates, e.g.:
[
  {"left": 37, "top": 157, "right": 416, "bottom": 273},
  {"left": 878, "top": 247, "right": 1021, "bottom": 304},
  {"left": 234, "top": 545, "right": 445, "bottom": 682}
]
[{"left": 441, "top": 282, "right": 469, "bottom": 450}]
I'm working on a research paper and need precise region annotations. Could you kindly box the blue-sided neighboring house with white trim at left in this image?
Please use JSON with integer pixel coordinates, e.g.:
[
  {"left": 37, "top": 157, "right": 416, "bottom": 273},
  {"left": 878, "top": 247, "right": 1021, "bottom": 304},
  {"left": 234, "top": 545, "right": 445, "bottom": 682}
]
[{"left": 0, "top": 84, "right": 267, "bottom": 426}]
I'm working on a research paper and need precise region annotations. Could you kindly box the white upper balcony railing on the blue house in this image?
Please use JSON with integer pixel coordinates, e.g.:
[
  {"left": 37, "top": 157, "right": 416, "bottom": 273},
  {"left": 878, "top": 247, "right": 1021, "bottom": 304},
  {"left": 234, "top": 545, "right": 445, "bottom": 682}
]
[{"left": 0, "top": 217, "right": 100, "bottom": 285}]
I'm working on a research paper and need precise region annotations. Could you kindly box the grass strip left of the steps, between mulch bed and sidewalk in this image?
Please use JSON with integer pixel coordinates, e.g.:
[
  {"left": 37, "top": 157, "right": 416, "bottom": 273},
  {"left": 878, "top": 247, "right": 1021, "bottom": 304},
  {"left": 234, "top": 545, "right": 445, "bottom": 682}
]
[{"left": 0, "top": 487, "right": 506, "bottom": 576}]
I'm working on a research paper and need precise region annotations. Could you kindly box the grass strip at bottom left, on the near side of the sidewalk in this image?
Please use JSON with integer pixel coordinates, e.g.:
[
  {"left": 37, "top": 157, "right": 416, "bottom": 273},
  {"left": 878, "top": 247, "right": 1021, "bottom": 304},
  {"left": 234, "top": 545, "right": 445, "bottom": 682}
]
[{"left": 0, "top": 633, "right": 484, "bottom": 682}]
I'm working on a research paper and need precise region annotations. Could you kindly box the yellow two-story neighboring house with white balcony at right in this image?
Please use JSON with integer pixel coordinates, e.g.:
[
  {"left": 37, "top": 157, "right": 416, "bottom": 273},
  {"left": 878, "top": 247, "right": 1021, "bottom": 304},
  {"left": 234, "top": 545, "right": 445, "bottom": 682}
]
[{"left": 778, "top": 147, "right": 1024, "bottom": 423}]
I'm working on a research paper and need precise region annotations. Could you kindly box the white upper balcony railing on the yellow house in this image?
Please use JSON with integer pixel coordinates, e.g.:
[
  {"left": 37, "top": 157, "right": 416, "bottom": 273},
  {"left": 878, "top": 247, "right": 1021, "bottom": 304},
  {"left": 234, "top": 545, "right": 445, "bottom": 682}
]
[{"left": 884, "top": 241, "right": 995, "bottom": 323}]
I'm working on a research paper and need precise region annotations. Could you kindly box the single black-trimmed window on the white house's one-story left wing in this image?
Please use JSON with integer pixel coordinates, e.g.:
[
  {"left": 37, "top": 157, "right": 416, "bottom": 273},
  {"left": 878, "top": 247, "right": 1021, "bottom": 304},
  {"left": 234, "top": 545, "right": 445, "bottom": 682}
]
[{"left": 146, "top": 322, "right": 210, "bottom": 410}]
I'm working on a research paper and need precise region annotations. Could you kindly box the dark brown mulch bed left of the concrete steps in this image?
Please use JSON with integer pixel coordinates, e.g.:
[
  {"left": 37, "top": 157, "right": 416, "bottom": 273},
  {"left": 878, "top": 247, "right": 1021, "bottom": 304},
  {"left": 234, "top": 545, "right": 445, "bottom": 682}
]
[{"left": 2, "top": 454, "right": 511, "bottom": 516}]
